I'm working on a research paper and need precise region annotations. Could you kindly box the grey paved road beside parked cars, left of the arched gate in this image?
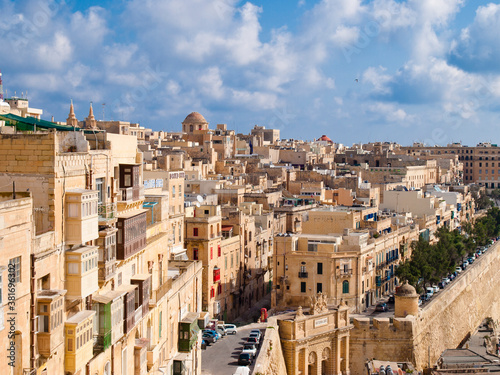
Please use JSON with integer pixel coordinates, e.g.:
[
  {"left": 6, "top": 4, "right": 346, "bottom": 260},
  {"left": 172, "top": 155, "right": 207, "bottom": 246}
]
[{"left": 201, "top": 323, "right": 267, "bottom": 375}]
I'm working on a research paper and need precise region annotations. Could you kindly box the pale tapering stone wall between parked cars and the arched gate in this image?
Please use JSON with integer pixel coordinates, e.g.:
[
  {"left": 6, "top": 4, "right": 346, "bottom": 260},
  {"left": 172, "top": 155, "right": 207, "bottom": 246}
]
[{"left": 253, "top": 317, "right": 286, "bottom": 375}]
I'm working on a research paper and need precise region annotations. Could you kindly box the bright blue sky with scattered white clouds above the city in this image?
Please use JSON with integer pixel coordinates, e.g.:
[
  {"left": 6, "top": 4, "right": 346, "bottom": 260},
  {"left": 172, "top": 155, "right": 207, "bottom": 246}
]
[{"left": 0, "top": 0, "right": 500, "bottom": 145}]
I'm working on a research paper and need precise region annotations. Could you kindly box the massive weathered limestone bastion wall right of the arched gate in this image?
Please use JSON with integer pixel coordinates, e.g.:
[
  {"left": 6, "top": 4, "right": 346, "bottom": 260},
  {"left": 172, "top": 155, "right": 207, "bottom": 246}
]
[{"left": 349, "top": 244, "right": 500, "bottom": 374}]
